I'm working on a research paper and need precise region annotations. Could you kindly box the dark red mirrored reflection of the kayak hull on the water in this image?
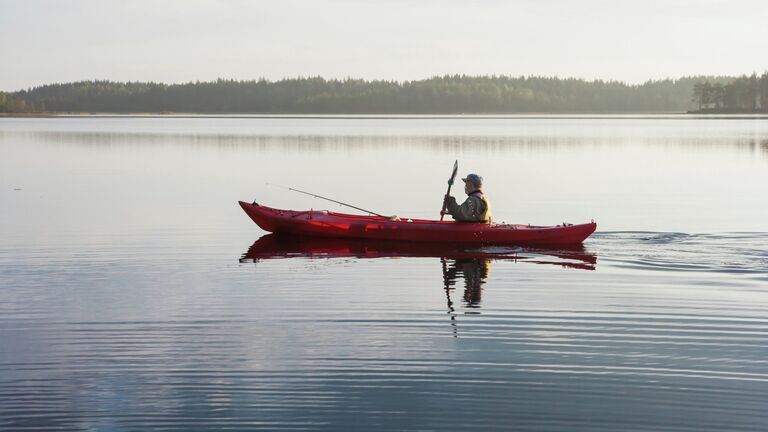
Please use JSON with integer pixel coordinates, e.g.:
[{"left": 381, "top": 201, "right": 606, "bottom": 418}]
[{"left": 240, "top": 234, "right": 597, "bottom": 270}]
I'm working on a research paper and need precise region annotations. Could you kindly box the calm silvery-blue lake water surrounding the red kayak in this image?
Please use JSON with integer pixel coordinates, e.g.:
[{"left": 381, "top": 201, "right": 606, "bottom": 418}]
[{"left": 0, "top": 116, "right": 768, "bottom": 431}]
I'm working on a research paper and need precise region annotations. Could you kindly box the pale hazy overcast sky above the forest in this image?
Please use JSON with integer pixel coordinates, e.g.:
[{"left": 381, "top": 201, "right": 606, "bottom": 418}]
[{"left": 0, "top": 0, "right": 768, "bottom": 91}]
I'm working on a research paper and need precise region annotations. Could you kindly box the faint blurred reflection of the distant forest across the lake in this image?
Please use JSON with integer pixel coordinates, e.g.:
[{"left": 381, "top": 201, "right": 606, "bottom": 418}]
[{"left": 9, "top": 130, "right": 768, "bottom": 153}]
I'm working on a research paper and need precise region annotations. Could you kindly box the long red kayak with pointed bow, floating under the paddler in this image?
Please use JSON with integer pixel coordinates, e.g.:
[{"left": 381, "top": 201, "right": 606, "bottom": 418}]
[{"left": 240, "top": 201, "right": 597, "bottom": 246}]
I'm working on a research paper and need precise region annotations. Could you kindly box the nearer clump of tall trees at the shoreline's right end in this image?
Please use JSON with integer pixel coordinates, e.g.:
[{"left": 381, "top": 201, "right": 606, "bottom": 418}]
[{"left": 692, "top": 72, "right": 768, "bottom": 113}]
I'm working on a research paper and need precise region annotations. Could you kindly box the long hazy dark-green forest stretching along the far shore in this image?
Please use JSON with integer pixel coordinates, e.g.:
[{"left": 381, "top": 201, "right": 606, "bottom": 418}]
[{"left": 0, "top": 74, "right": 768, "bottom": 114}]
